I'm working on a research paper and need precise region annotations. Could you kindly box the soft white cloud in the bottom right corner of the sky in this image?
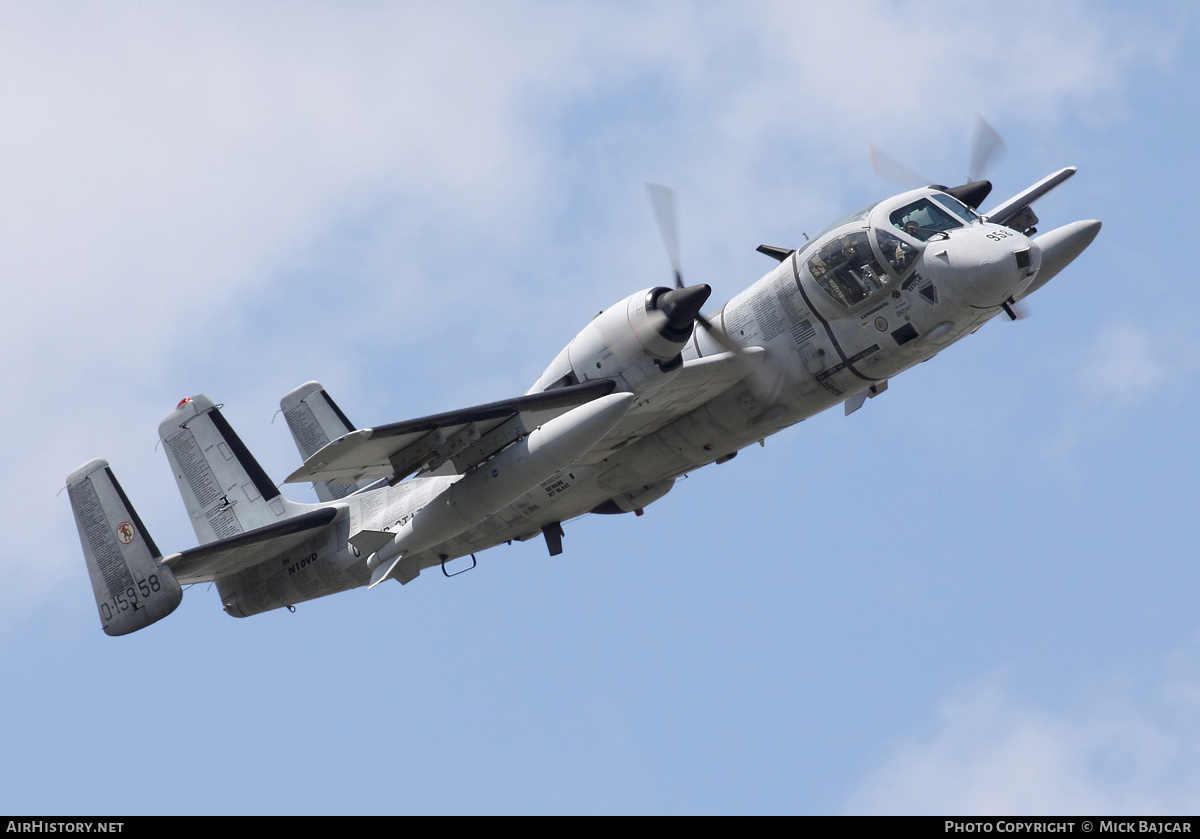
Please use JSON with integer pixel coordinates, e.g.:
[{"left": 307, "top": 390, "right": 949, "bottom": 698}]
[{"left": 846, "top": 667, "right": 1200, "bottom": 815}]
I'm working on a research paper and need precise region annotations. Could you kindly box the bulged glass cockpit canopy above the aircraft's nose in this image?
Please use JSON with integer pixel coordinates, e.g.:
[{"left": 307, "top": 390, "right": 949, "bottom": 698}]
[{"left": 808, "top": 188, "right": 982, "bottom": 308}]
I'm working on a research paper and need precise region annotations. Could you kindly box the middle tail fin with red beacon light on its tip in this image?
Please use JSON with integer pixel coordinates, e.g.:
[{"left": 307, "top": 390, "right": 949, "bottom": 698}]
[{"left": 158, "top": 394, "right": 304, "bottom": 545}]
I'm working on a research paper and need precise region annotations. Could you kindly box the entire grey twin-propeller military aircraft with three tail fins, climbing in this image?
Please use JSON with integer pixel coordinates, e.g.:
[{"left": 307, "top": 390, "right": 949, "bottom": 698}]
[{"left": 67, "top": 131, "right": 1100, "bottom": 635}]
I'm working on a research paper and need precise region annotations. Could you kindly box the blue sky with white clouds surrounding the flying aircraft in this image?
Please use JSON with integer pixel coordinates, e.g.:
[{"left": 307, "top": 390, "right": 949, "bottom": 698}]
[{"left": 0, "top": 2, "right": 1200, "bottom": 814}]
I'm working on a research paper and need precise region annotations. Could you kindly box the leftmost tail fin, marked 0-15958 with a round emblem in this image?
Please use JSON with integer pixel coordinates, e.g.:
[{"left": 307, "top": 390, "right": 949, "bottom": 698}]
[{"left": 67, "top": 460, "right": 184, "bottom": 635}]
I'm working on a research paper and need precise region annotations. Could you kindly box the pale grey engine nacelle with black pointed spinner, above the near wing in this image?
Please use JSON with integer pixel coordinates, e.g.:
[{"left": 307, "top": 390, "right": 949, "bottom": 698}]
[{"left": 529, "top": 286, "right": 713, "bottom": 392}]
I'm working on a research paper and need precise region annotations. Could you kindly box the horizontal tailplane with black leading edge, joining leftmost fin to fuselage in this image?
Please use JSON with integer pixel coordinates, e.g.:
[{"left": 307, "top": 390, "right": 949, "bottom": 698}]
[{"left": 161, "top": 507, "right": 337, "bottom": 586}]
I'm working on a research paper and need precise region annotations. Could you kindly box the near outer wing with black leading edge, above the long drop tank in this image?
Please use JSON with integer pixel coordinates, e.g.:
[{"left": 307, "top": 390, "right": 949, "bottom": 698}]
[{"left": 284, "top": 379, "right": 617, "bottom": 484}]
